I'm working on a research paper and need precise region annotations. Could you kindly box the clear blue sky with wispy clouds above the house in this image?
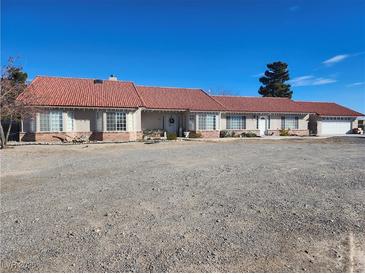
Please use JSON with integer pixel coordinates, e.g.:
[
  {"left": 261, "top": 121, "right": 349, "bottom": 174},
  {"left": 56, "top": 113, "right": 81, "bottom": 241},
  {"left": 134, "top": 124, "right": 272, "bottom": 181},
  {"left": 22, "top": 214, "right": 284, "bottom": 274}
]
[{"left": 1, "top": 0, "right": 365, "bottom": 113}]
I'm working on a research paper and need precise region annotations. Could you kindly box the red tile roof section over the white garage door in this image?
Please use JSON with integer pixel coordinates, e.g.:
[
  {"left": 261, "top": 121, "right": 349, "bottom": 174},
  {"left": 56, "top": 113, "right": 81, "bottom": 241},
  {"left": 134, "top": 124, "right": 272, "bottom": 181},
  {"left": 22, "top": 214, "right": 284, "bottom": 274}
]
[{"left": 296, "top": 101, "right": 365, "bottom": 117}]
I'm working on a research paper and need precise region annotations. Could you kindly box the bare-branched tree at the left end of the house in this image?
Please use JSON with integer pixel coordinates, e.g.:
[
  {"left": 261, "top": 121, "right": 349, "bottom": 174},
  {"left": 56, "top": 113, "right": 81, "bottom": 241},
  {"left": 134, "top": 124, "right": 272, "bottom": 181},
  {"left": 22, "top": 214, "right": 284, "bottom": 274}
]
[{"left": 0, "top": 58, "right": 34, "bottom": 148}]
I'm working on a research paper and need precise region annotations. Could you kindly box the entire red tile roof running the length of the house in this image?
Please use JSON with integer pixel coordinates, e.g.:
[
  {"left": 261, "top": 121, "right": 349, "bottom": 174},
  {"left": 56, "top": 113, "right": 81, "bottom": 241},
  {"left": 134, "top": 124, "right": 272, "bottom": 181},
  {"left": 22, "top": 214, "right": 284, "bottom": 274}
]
[{"left": 18, "top": 76, "right": 365, "bottom": 116}]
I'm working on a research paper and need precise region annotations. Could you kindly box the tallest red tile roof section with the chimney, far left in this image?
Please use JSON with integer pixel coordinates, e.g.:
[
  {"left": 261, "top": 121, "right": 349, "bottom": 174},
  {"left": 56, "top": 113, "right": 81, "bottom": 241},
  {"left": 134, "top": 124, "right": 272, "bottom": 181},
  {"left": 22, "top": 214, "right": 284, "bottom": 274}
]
[{"left": 19, "top": 76, "right": 142, "bottom": 108}]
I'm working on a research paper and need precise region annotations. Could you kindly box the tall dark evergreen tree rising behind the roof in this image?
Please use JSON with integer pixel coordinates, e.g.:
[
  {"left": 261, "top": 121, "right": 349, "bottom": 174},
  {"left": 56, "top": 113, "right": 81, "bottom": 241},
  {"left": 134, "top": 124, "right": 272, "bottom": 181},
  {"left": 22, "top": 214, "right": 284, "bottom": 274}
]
[{"left": 259, "top": 61, "right": 293, "bottom": 98}]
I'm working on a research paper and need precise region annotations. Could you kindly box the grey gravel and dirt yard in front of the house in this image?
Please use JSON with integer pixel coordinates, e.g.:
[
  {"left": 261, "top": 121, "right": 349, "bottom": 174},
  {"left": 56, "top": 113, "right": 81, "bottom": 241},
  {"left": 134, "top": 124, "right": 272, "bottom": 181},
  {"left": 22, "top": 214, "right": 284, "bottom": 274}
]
[{"left": 0, "top": 138, "right": 365, "bottom": 272}]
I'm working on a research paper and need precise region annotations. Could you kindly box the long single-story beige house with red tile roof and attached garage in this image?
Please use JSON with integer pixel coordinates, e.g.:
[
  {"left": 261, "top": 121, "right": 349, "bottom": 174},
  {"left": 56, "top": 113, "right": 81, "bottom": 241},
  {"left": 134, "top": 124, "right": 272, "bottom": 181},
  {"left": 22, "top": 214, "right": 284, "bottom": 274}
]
[{"left": 18, "top": 76, "right": 364, "bottom": 142}]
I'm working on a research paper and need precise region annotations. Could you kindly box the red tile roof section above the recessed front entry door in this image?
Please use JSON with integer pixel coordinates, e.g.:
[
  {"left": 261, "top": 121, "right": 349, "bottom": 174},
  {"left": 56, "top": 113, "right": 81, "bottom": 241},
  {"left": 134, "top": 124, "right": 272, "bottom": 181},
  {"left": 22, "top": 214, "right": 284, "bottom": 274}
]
[{"left": 136, "top": 86, "right": 225, "bottom": 111}]
